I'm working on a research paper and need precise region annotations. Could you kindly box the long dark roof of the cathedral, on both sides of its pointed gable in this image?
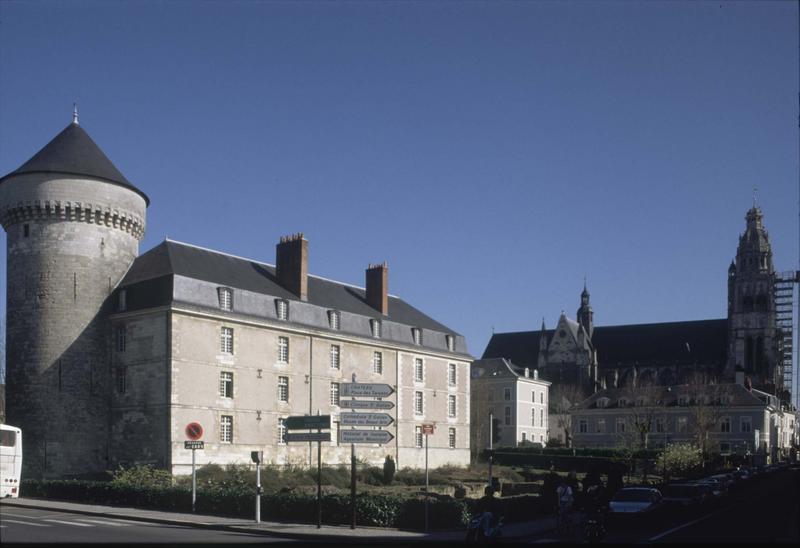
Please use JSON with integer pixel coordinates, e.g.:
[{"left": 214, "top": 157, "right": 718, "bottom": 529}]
[{"left": 482, "top": 319, "right": 728, "bottom": 369}]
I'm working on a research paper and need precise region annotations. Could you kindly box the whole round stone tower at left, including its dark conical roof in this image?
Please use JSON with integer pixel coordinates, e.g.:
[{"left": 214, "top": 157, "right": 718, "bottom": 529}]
[{"left": 0, "top": 114, "right": 149, "bottom": 478}]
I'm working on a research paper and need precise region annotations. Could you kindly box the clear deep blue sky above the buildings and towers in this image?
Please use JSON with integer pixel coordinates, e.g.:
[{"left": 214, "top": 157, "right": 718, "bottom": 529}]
[{"left": 0, "top": 1, "right": 799, "bottom": 368}]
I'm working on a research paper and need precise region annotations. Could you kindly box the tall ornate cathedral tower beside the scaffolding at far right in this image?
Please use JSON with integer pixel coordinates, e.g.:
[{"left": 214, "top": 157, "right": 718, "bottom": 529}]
[{"left": 726, "top": 204, "right": 782, "bottom": 393}]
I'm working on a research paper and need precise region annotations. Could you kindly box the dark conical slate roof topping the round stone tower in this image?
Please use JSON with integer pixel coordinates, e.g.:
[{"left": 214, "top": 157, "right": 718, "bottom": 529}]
[{"left": 0, "top": 122, "right": 150, "bottom": 205}]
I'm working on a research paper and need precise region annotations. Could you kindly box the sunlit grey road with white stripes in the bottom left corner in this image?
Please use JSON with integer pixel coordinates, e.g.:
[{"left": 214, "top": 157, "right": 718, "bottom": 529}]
[{"left": 0, "top": 507, "right": 295, "bottom": 544}]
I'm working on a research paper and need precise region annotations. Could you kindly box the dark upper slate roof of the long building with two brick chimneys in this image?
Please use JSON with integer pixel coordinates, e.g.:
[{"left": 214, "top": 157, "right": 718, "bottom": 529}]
[{"left": 120, "top": 240, "right": 458, "bottom": 335}]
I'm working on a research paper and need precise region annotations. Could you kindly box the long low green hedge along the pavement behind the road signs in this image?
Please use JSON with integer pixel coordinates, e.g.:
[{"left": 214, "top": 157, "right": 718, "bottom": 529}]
[{"left": 21, "top": 480, "right": 470, "bottom": 529}]
